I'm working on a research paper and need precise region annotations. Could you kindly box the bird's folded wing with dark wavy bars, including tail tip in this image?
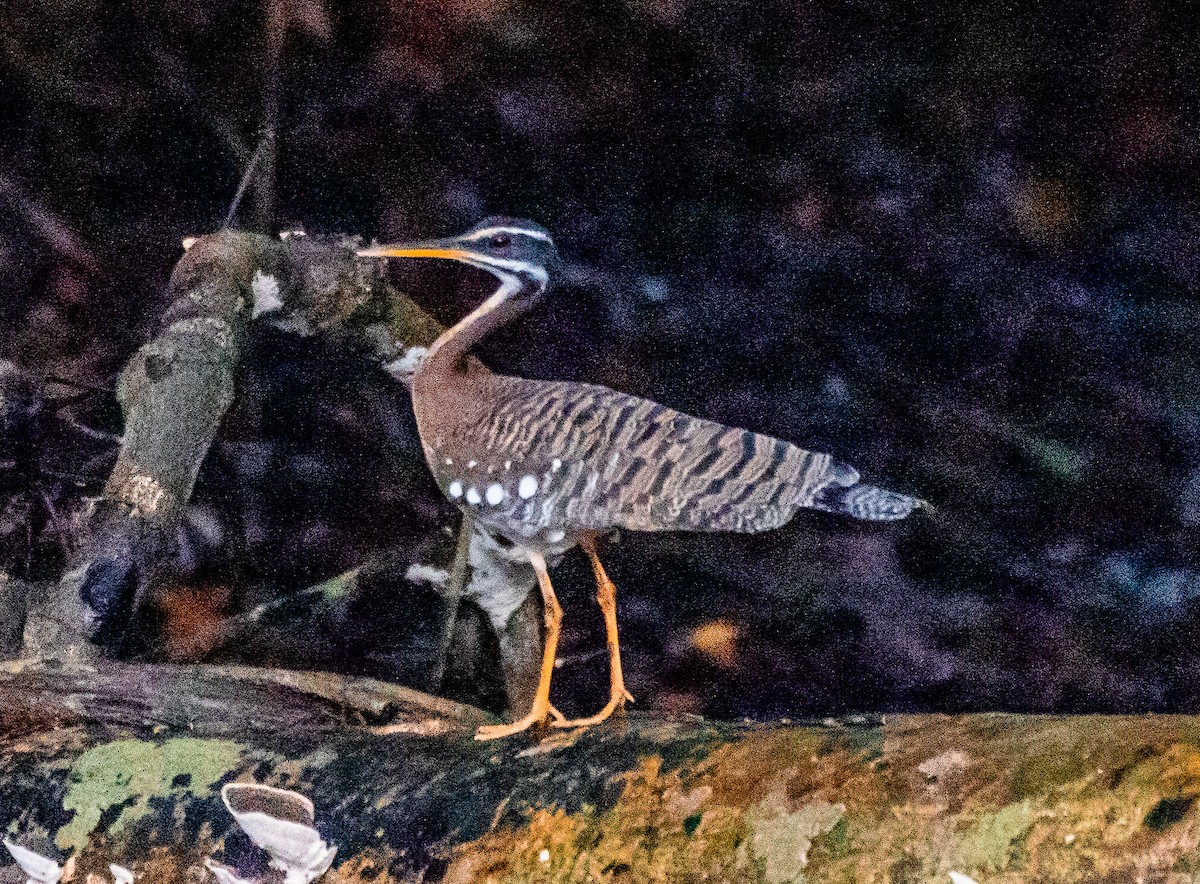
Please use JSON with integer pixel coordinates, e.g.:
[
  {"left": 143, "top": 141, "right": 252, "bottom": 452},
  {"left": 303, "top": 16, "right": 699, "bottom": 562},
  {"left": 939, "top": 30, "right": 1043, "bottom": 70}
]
[{"left": 473, "top": 378, "right": 917, "bottom": 531}]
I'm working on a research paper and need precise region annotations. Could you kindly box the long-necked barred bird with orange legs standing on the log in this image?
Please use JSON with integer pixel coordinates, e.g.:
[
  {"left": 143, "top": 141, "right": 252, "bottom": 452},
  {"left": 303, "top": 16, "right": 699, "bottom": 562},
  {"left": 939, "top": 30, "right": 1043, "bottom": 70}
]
[{"left": 358, "top": 216, "right": 928, "bottom": 740}]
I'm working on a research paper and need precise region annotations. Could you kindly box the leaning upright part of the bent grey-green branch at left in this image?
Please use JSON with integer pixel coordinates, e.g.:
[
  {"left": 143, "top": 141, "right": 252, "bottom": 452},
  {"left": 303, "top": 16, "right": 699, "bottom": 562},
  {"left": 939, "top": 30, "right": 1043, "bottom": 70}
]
[{"left": 24, "top": 230, "right": 283, "bottom": 659}]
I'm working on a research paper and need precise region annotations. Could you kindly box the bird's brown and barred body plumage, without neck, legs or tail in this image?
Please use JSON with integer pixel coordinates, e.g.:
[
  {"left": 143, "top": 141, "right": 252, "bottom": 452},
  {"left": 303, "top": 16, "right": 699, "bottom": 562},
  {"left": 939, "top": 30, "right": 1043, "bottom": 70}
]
[{"left": 415, "top": 372, "right": 857, "bottom": 536}]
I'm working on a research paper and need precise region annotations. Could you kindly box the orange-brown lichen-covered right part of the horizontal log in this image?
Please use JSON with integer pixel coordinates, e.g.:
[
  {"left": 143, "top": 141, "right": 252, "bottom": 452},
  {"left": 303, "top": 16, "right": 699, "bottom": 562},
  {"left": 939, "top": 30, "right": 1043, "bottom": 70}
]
[{"left": 446, "top": 716, "right": 1200, "bottom": 884}]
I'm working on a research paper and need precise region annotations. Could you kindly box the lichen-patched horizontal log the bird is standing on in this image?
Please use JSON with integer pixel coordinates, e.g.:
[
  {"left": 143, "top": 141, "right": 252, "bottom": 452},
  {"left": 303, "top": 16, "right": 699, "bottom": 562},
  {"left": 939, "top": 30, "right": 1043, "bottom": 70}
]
[{"left": 0, "top": 661, "right": 1200, "bottom": 884}]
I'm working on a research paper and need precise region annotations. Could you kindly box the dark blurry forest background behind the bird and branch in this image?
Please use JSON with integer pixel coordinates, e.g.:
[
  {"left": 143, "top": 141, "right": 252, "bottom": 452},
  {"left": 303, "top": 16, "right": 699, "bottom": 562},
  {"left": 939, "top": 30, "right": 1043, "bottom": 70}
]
[{"left": 0, "top": 0, "right": 1200, "bottom": 716}]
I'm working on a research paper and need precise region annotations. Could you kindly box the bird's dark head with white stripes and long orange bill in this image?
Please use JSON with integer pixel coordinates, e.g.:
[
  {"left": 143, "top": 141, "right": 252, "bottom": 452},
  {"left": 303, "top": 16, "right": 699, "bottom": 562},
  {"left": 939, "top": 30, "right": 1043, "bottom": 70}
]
[{"left": 358, "top": 216, "right": 558, "bottom": 297}]
